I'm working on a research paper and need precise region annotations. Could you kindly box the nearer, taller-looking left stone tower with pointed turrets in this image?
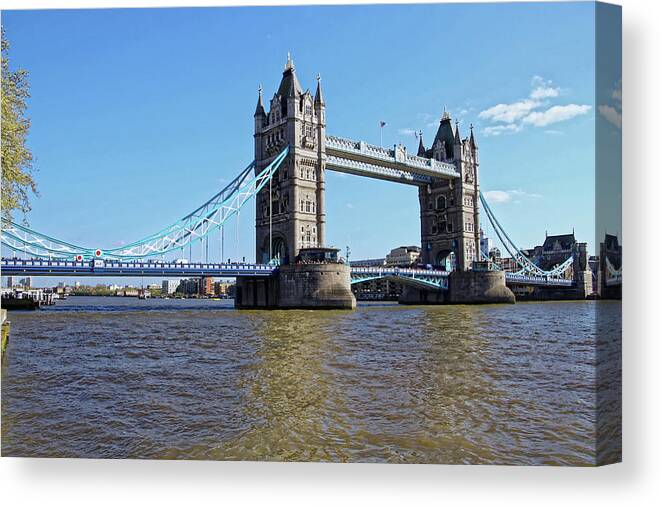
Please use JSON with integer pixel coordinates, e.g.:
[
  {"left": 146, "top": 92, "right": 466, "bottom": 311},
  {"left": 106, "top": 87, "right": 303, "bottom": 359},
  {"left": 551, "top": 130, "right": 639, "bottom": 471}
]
[{"left": 254, "top": 55, "right": 326, "bottom": 264}]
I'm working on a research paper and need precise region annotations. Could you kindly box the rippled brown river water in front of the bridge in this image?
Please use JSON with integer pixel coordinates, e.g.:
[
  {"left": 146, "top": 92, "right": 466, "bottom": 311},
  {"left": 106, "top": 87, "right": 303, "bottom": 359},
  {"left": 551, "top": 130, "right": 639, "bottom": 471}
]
[{"left": 2, "top": 297, "right": 621, "bottom": 465}]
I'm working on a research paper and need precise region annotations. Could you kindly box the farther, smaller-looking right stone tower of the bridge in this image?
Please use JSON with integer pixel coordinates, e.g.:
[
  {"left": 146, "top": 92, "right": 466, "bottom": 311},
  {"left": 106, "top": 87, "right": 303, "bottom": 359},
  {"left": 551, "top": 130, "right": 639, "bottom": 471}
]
[{"left": 418, "top": 111, "right": 480, "bottom": 271}]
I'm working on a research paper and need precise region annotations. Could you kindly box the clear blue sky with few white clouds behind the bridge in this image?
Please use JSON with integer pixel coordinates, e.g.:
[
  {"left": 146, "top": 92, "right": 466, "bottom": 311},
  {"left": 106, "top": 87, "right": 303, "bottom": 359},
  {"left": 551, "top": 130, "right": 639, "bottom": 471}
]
[{"left": 3, "top": 2, "right": 621, "bottom": 284}]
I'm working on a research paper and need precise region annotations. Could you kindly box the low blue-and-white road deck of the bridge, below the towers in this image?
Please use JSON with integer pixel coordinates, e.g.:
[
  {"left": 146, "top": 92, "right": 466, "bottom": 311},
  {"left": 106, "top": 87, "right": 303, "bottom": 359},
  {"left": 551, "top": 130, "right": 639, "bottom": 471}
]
[{"left": 0, "top": 258, "right": 574, "bottom": 290}]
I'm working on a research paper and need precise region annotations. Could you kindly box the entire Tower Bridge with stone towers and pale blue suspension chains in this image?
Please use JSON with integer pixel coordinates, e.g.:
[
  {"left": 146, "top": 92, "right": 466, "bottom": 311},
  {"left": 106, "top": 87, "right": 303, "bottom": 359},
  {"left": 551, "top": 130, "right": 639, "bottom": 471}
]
[{"left": 1, "top": 58, "right": 614, "bottom": 308}]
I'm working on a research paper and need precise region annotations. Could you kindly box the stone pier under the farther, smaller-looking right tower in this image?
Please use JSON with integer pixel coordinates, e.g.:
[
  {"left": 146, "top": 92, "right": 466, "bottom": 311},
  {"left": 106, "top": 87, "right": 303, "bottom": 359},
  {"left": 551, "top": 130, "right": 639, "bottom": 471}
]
[{"left": 399, "top": 271, "right": 516, "bottom": 304}]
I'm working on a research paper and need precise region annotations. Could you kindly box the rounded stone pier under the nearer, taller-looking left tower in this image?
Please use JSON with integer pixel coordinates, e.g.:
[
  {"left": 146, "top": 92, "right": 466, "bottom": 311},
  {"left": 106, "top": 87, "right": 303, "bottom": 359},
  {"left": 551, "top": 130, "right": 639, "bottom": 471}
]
[{"left": 234, "top": 263, "right": 356, "bottom": 309}]
